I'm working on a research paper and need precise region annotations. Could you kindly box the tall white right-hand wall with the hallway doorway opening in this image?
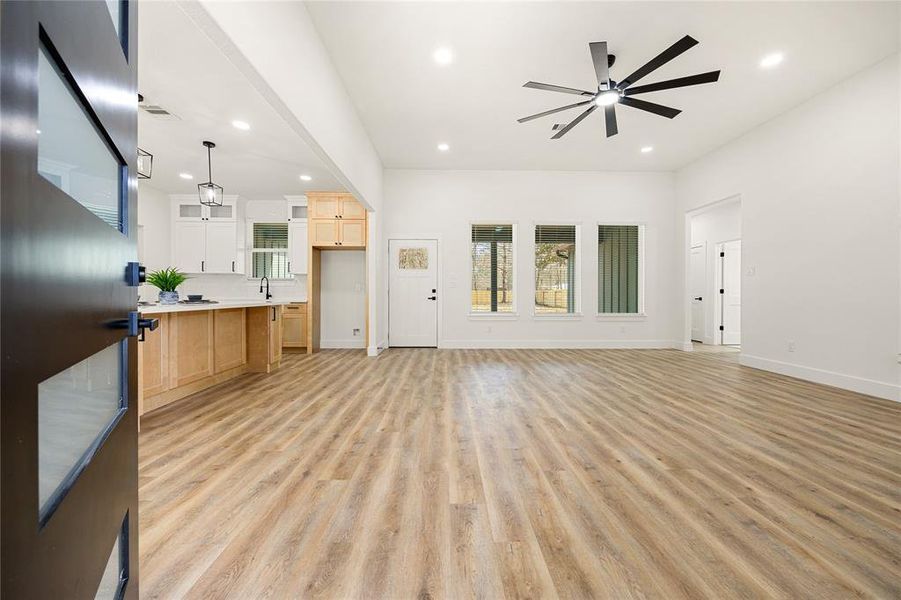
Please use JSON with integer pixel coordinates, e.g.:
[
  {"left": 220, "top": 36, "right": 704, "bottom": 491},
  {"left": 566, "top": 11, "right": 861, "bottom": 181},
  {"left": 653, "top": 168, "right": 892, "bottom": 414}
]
[{"left": 674, "top": 56, "right": 901, "bottom": 399}]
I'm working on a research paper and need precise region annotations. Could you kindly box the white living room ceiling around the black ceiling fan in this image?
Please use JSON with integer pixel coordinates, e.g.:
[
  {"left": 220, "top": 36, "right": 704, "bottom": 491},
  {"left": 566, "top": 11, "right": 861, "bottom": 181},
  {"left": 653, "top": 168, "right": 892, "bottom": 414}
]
[{"left": 307, "top": 2, "right": 899, "bottom": 170}]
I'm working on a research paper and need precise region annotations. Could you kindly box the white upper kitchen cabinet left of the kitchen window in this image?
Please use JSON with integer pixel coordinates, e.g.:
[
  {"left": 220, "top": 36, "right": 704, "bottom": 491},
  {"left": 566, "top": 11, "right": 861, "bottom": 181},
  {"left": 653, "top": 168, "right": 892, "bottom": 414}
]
[{"left": 172, "top": 194, "right": 244, "bottom": 273}]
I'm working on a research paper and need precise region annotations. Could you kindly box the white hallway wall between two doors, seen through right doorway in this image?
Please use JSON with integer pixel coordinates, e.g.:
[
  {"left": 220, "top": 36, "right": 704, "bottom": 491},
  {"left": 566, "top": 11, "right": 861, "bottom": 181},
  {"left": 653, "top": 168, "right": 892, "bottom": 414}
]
[{"left": 689, "top": 199, "right": 741, "bottom": 344}]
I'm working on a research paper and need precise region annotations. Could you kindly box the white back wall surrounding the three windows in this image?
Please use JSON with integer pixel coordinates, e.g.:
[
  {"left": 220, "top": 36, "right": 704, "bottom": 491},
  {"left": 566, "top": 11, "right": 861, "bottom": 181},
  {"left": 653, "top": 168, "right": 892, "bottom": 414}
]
[{"left": 381, "top": 170, "right": 677, "bottom": 347}]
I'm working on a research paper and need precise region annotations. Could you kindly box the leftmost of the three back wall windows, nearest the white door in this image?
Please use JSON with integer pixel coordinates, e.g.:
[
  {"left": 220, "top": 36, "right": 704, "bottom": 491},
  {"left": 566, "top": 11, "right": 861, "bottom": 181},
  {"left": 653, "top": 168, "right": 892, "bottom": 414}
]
[{"left": 470, "top": 225, "right": 513, "bottom": 313}]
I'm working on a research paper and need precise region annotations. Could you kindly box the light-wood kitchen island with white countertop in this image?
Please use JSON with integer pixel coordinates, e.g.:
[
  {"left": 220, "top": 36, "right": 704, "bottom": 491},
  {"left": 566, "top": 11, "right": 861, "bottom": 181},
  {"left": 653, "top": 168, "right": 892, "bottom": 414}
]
[{"left": 138, "top": 300, "right": 289, "bottom": 422}]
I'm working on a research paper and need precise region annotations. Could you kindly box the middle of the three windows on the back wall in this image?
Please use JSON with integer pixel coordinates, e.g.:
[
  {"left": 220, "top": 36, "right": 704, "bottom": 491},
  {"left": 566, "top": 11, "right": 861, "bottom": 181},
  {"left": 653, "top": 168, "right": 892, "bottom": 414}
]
[{"left": 535, "top": 225, "right": 578, "bottom": 314}]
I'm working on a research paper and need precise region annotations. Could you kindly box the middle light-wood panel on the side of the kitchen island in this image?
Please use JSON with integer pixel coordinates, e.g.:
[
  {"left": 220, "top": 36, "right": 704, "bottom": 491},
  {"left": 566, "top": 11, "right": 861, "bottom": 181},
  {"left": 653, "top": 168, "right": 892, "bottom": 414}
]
[{"left": 169, "top": 310, "right": 214, "bottom": 387}]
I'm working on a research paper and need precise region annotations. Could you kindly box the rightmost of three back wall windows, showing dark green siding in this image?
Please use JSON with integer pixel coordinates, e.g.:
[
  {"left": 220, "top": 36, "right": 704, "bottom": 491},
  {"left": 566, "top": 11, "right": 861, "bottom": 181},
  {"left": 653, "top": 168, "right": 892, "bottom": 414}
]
[{"left": 598, "top": 225, "right": 643, "bottom": 314}]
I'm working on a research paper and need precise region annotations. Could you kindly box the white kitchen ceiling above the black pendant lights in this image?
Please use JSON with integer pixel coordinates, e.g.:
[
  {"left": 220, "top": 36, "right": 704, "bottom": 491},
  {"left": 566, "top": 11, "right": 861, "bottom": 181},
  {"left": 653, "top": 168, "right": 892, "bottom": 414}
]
[{"left": 138, "top": 2, "right": 343, "bottom": 199}]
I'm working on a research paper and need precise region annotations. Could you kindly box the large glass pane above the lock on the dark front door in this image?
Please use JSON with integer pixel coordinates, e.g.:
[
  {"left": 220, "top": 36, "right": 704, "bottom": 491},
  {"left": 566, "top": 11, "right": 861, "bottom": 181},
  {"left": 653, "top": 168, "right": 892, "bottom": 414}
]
[{"left": 37, "top": 48, "right": 122, "bottom": 231}]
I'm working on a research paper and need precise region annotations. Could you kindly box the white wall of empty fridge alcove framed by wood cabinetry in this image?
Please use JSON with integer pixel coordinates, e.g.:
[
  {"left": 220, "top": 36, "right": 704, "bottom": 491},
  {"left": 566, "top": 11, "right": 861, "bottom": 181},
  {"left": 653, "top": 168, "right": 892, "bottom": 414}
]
[{"left": 319, "top": 251, "right": 366, "bottom": 348}]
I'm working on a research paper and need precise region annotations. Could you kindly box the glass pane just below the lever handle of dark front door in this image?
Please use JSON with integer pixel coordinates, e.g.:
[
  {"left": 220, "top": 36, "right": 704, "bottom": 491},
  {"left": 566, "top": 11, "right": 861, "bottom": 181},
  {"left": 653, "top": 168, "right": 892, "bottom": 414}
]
[{"left": 38, "top": 340, "right": 126, "bottom": 521}]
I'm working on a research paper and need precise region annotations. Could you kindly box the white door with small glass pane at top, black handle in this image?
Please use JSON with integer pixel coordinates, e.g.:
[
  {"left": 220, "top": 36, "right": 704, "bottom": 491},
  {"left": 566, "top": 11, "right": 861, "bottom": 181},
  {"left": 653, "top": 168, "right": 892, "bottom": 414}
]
[{"left": 388, "top": 240, "right": 438, "bottom": 348}]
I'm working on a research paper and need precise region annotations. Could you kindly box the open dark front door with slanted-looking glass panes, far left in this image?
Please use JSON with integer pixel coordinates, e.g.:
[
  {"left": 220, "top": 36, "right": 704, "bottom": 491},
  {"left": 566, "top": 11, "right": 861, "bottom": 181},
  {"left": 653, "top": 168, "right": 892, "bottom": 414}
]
[{"left": 0, "top": 0, "right": 138, "bottom": 599}]
